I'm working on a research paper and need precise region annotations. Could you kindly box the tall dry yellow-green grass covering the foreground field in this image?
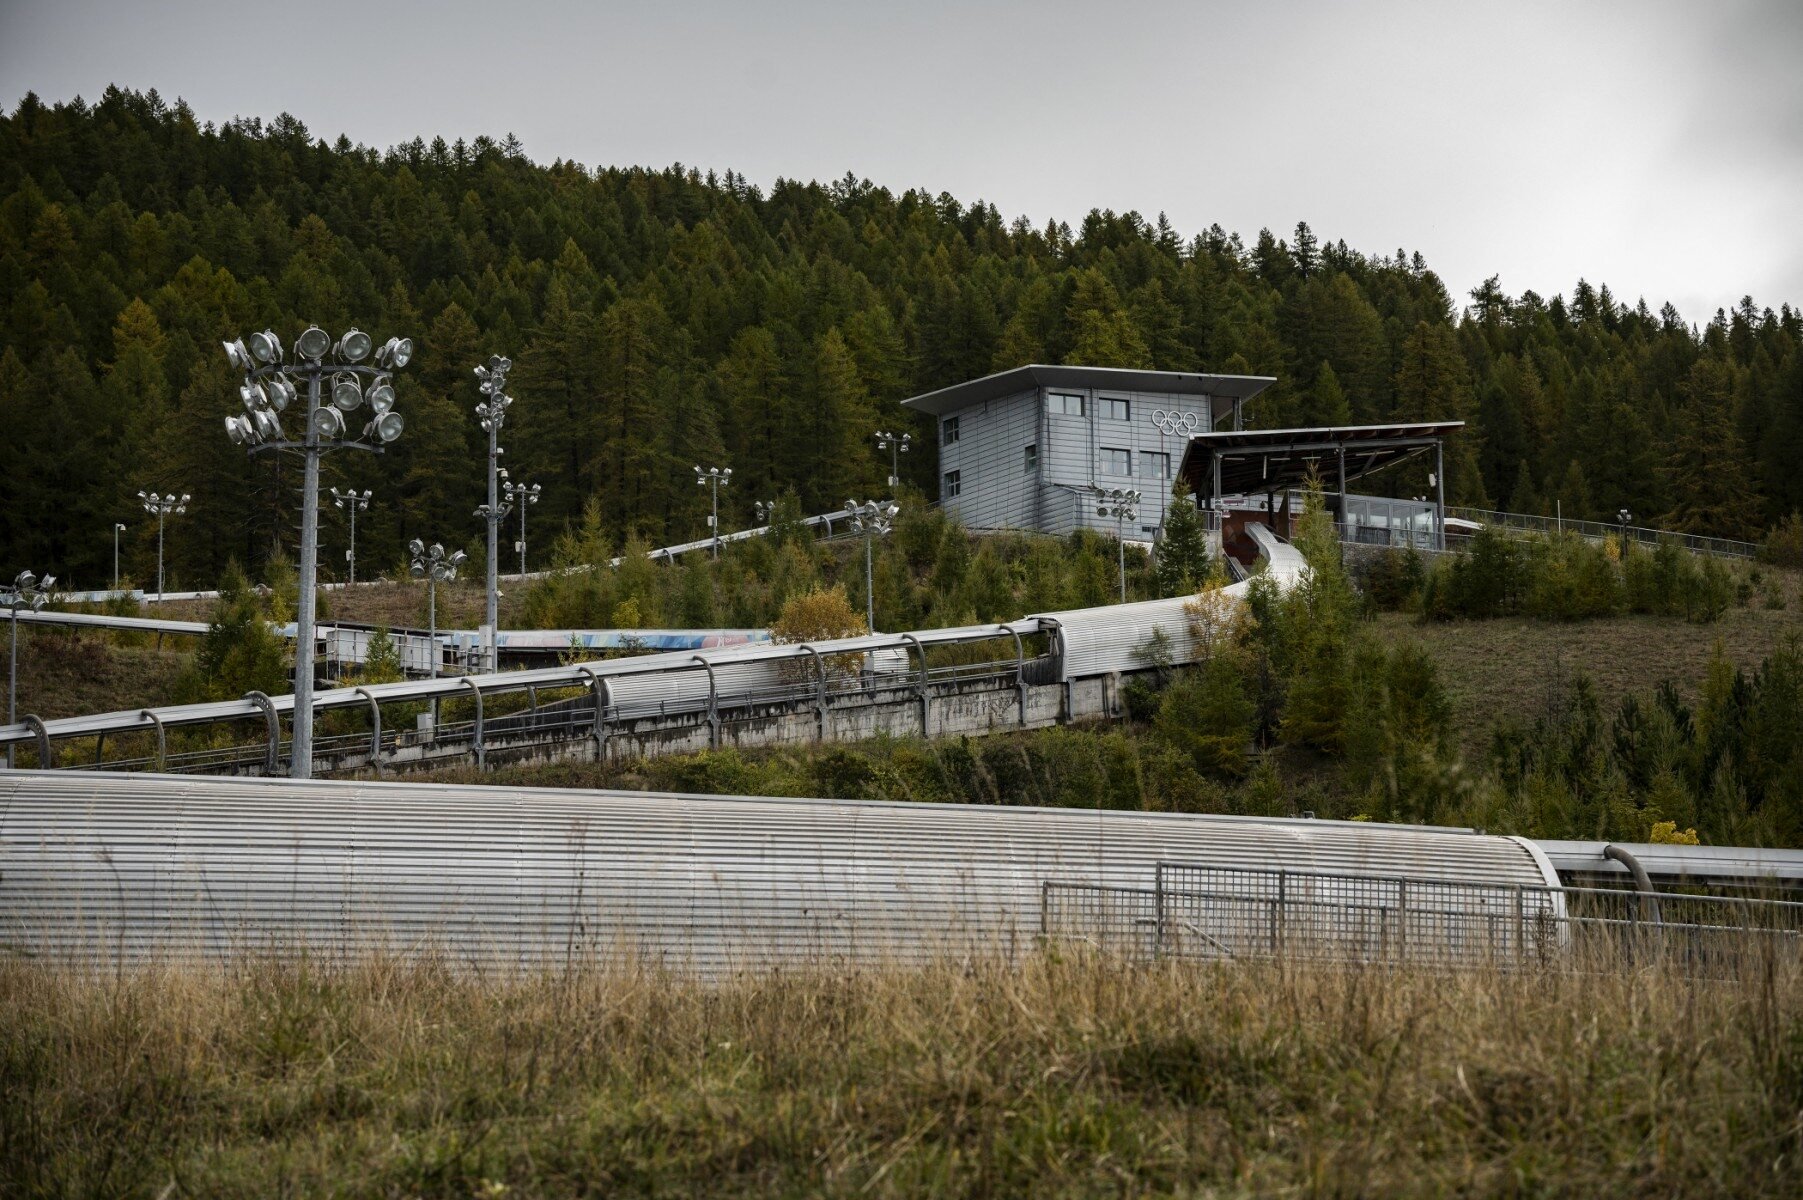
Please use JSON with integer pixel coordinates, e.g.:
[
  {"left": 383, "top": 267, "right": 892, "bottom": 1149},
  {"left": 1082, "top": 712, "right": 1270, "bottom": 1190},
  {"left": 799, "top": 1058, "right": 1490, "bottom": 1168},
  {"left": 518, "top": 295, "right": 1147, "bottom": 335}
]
[{"left": 0, "top": 953, "right": 1803, "bottom": 1196}]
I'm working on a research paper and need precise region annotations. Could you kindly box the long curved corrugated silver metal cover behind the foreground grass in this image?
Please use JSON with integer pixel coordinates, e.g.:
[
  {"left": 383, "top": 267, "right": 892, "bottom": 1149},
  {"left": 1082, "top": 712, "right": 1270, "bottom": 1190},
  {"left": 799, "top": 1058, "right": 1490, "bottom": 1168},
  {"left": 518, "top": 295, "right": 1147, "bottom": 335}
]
[{"left": 0, "top": 771, "right": 1558, "bottom": 971}]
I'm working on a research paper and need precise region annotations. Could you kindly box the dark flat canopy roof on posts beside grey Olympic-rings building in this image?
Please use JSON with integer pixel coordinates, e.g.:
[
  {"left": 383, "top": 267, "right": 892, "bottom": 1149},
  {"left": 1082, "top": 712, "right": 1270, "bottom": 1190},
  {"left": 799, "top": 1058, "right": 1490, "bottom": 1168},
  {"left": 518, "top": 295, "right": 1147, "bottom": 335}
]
[{"left": 1177, "top": 422, "right": 1464, "bottom": 499}]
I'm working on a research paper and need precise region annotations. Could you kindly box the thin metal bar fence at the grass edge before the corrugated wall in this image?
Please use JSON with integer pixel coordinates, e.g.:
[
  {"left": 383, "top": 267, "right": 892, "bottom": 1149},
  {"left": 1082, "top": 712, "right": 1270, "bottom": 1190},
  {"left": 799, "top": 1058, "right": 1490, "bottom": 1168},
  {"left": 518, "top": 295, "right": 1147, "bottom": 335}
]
[{"left": 1040, "top": 863, "right": 1803, "bottom": 973}]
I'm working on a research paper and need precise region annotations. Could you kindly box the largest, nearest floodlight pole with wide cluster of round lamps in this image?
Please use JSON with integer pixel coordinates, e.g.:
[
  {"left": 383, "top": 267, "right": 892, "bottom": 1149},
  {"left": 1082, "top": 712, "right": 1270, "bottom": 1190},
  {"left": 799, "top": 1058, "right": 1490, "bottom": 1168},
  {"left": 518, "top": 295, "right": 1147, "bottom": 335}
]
[{"left": 221, "top": 324, "right": 413, "bottom": 778}]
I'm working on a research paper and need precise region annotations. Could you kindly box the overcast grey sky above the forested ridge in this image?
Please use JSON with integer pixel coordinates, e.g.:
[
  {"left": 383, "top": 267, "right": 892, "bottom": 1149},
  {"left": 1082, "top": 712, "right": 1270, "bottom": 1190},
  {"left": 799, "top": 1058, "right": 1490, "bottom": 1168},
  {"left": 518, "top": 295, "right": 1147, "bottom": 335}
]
[{"left": 0, "top": 0, "right": 1803, "bottom": 321}]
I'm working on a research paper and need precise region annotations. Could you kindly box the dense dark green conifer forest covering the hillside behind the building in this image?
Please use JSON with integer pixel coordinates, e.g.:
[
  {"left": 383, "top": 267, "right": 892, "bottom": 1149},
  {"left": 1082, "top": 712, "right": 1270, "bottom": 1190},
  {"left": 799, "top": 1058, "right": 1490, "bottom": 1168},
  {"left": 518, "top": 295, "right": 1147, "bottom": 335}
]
[{"left": 0, "top": 88, "right": 1803, "bottom": 586}]
